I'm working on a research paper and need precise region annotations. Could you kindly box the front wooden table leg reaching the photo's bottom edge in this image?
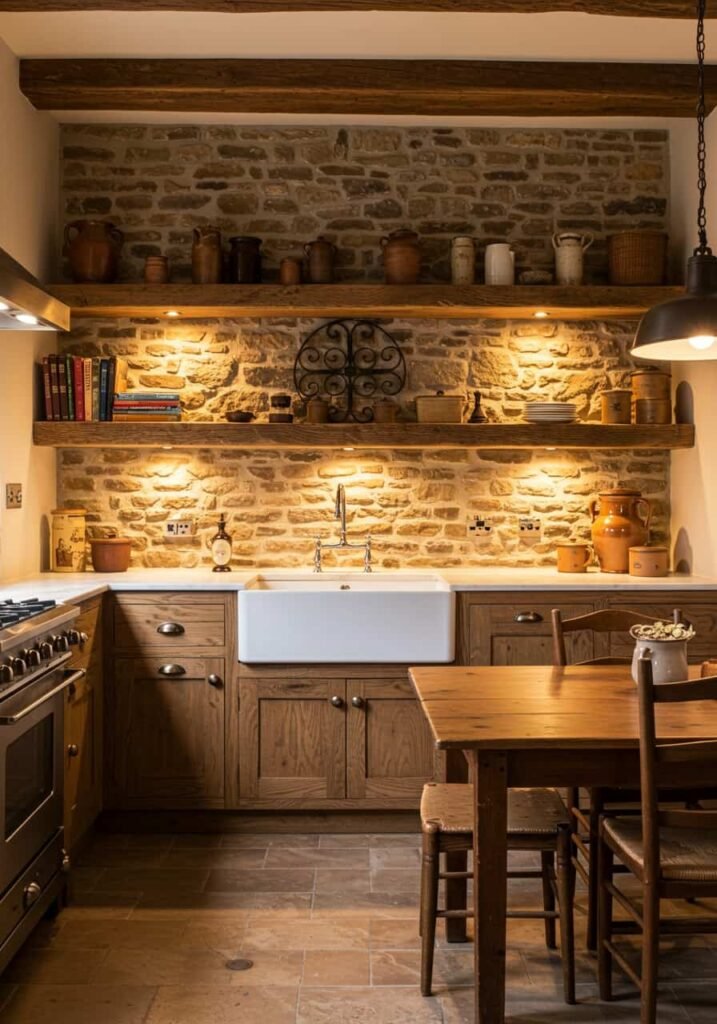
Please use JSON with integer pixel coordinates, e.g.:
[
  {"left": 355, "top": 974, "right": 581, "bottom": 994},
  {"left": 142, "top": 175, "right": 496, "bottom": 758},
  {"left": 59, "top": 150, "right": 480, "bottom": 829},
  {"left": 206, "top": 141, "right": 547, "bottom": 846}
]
[{"left": 471, "top": 751, "right": 508, "bottom": 1024}]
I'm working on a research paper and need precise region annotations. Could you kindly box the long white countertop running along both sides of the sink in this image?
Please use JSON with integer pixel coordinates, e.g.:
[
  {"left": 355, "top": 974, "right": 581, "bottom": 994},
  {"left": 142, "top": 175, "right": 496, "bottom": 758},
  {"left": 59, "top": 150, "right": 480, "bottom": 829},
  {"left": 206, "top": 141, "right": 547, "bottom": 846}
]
[{"left": 0, "top": 567, "right": 717, "bottom": 601}]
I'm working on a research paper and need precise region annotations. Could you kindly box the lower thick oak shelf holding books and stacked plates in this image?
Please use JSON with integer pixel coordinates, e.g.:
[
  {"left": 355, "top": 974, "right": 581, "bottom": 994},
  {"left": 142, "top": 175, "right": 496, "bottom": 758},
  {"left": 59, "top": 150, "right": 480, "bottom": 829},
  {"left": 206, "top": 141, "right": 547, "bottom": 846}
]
[{"left": 34, "top": 421, "right": 694, "bottom": 451}]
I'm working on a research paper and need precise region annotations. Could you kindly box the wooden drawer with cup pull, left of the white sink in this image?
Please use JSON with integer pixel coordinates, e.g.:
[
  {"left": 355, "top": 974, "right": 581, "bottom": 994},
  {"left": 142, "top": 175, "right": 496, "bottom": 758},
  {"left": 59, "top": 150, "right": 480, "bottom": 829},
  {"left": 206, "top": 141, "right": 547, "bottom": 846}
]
[{"left": 113, "top": 595, "right": 226, "bottom": 650}]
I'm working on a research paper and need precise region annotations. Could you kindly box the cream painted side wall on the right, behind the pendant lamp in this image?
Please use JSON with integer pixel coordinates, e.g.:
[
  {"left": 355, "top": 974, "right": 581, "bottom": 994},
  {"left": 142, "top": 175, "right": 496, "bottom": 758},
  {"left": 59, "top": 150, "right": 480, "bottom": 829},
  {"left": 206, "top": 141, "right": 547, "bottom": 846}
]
[{"left": 671, "top": 116, "right": 717, "bottom": 574}]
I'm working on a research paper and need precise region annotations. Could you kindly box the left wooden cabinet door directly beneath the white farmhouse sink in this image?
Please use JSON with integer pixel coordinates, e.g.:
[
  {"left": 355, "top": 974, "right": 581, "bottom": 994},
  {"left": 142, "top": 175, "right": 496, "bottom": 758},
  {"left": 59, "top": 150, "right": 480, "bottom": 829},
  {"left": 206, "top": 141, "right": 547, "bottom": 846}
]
[{"left": 240, "top": 678, "right": 346, "bottom": 801}]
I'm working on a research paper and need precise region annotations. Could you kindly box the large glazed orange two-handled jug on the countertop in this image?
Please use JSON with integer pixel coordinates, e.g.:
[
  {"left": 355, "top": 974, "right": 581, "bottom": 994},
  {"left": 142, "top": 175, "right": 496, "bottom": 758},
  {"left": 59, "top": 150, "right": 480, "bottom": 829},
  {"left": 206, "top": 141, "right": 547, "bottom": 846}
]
[{"left": 590, "top": 487, "right": 652, "bottom": 572}]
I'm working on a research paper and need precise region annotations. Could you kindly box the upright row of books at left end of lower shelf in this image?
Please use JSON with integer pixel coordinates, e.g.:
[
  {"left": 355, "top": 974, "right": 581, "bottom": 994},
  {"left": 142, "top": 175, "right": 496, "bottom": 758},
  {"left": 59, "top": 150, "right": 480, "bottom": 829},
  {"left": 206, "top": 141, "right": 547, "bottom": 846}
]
[{"left": 42, "top": 355, "right": 127, "bottom": 421}]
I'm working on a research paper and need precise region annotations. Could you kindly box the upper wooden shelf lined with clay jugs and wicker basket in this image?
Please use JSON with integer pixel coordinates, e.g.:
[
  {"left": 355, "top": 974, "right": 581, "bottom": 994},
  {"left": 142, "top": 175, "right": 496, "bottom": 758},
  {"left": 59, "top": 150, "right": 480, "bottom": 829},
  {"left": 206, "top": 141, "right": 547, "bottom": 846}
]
[{"left": 48, "top": 284, "right": 684, "bottom": 321}]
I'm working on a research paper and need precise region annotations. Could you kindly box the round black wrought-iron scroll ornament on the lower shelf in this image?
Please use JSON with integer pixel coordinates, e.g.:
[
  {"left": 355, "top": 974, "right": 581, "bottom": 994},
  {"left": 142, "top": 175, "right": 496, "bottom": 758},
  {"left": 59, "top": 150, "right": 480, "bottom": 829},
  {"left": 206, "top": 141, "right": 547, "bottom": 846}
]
[{"left": 294, "top": 319, "right": 406, "bottom": 423}]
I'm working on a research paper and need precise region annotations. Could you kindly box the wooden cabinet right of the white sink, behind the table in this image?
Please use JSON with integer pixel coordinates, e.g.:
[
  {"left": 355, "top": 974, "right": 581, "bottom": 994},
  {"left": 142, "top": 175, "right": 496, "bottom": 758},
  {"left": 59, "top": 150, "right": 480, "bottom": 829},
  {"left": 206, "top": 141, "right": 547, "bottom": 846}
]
[{"left": 456, "top": 593, "right": 598, "bottom": 665}]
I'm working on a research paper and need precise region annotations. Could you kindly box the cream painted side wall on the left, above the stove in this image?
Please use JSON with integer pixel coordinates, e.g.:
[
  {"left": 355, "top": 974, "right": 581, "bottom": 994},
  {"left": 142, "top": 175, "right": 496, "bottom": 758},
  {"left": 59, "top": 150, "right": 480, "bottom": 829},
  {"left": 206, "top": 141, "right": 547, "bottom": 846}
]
[{"left": 0, "top": 40, "right": 58, "bottom": 583}]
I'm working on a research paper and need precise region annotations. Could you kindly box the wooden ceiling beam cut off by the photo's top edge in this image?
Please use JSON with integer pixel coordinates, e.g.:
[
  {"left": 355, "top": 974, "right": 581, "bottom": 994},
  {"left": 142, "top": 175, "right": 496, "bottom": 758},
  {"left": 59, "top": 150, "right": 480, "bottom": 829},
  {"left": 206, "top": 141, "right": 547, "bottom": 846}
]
[{"left": 2, "top": 0, "right": 717, "bottom": 18}]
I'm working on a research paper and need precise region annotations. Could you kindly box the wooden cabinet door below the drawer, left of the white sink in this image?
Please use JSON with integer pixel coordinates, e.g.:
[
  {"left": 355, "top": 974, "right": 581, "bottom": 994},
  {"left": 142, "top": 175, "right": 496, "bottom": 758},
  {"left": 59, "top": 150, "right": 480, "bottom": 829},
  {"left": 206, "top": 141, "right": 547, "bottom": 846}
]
[{"left": 106, "top": 657, "right": 224, "bottom": 809}]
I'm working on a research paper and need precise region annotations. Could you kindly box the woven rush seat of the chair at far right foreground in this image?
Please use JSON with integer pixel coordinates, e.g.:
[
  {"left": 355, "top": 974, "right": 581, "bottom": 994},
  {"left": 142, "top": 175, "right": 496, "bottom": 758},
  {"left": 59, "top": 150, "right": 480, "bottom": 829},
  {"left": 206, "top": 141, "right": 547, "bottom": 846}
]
[{"left": 603, "top": 817, "right": 717, "bottom": 882}]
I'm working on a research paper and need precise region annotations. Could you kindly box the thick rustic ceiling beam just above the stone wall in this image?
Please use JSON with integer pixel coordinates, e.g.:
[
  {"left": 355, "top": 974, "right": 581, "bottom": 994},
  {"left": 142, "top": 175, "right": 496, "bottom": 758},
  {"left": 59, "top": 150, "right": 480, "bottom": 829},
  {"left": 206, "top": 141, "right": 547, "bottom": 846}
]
[{"left": 19, "top": 58, "right": 717, "bottom": 117}]
